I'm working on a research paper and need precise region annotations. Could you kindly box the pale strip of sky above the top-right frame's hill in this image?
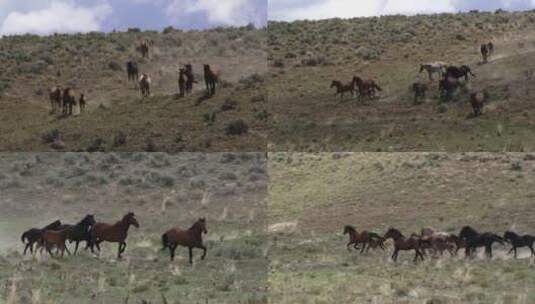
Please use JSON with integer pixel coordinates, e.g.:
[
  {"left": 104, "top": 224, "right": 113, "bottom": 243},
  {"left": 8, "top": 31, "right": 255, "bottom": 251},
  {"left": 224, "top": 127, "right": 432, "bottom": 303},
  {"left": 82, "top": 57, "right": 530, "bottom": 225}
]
[{"left": 268, "top": 0, "right": 535, "bottom": 21}]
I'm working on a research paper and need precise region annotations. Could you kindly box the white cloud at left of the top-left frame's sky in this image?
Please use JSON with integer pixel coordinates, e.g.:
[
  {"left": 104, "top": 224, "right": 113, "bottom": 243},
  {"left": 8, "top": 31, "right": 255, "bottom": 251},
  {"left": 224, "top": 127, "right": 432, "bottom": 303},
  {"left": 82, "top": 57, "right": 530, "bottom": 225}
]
[{"left": 0, "top": 1, "right": 112, "bottom": 35}]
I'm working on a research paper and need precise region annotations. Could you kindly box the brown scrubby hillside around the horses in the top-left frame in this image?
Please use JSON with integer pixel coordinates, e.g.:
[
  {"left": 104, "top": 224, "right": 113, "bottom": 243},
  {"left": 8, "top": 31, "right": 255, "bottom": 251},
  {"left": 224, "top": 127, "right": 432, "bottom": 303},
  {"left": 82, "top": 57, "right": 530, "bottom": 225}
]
[{"left": 0, "top": 27, "right": 267, "bottom": 152}]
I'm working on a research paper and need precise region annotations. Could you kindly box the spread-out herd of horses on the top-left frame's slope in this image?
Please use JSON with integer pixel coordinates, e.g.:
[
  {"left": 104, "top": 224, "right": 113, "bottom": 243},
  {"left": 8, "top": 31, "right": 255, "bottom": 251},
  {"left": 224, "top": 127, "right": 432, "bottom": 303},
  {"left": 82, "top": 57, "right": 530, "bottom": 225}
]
[{"left": 49, "top": 40, "right": 221, "bottom": 116}]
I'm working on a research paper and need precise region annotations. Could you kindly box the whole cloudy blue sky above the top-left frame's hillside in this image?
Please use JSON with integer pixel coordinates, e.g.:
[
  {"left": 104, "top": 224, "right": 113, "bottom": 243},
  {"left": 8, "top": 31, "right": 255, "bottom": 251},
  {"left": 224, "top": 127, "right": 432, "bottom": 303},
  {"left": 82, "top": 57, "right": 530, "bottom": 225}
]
[{"left": 0, "top": 0, "right": 267, "bottom": 36}]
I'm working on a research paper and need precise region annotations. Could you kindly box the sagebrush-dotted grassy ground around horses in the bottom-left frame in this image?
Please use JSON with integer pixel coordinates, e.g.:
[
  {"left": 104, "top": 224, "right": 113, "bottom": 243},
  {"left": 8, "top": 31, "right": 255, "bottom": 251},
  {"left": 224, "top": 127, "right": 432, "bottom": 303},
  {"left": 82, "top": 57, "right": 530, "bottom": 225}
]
[{"left": 0, "top": 153, "right": 268, "bottom": 303}]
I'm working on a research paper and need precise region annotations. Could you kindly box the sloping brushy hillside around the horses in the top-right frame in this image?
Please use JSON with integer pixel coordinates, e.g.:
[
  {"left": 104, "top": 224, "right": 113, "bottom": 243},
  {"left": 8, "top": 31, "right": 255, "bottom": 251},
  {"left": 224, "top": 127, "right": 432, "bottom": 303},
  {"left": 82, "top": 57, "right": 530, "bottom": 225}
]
[{"left": 268, "top": 12, "right": 535, "bottom": 151}]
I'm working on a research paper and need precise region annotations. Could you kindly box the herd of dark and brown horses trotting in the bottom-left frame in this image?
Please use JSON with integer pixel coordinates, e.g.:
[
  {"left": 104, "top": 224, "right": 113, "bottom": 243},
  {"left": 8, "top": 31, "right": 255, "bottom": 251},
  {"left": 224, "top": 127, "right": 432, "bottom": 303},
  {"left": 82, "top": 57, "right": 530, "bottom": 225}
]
[{"left": 21, "top": 212, "right": 208, "bottom": 264}]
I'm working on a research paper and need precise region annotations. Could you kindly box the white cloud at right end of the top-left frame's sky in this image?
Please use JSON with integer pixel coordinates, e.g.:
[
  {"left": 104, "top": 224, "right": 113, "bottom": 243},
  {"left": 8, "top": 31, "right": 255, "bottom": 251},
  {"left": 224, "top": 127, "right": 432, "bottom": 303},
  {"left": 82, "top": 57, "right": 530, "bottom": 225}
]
[{"left": 166, "top": 0, "right": 266, "bottom": 25}]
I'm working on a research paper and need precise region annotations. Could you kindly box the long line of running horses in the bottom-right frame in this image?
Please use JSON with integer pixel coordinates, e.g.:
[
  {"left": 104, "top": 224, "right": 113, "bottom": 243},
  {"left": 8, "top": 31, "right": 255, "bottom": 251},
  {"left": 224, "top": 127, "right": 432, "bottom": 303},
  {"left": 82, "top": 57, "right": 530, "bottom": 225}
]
[{"left": 344, "top": 225, "right": 535, "bottom": 262}]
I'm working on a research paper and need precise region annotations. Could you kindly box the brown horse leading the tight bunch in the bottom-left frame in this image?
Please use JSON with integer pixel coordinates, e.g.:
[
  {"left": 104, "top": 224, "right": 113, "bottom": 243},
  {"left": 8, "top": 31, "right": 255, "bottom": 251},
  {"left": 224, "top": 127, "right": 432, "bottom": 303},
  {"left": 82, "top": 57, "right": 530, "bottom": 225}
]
[{"left": 90, "top": 212, "right": 139, "bottom": 259}]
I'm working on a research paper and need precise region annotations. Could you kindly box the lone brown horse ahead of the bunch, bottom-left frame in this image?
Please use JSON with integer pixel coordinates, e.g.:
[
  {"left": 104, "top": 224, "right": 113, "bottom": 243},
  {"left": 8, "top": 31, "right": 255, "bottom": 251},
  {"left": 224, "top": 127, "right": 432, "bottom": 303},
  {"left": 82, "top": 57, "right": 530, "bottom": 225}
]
[{"left": 162, "top": 217, "right": 208, "bottom": 264}]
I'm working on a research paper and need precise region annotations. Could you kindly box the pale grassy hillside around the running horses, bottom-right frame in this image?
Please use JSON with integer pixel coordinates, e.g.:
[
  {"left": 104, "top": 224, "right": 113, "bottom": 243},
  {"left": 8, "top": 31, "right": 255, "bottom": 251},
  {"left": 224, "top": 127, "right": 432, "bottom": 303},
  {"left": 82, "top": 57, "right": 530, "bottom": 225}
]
[{"left": 268, "top": 153, "right": 535, "bottom": 303}]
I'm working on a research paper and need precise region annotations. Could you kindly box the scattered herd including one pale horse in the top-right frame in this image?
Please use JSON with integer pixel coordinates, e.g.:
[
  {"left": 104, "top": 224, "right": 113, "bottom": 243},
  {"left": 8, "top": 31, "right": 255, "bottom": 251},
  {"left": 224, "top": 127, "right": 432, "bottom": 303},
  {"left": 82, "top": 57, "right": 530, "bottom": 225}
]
[{"left": 331, "top": 42, "right": 494, "bottom": 116}]
